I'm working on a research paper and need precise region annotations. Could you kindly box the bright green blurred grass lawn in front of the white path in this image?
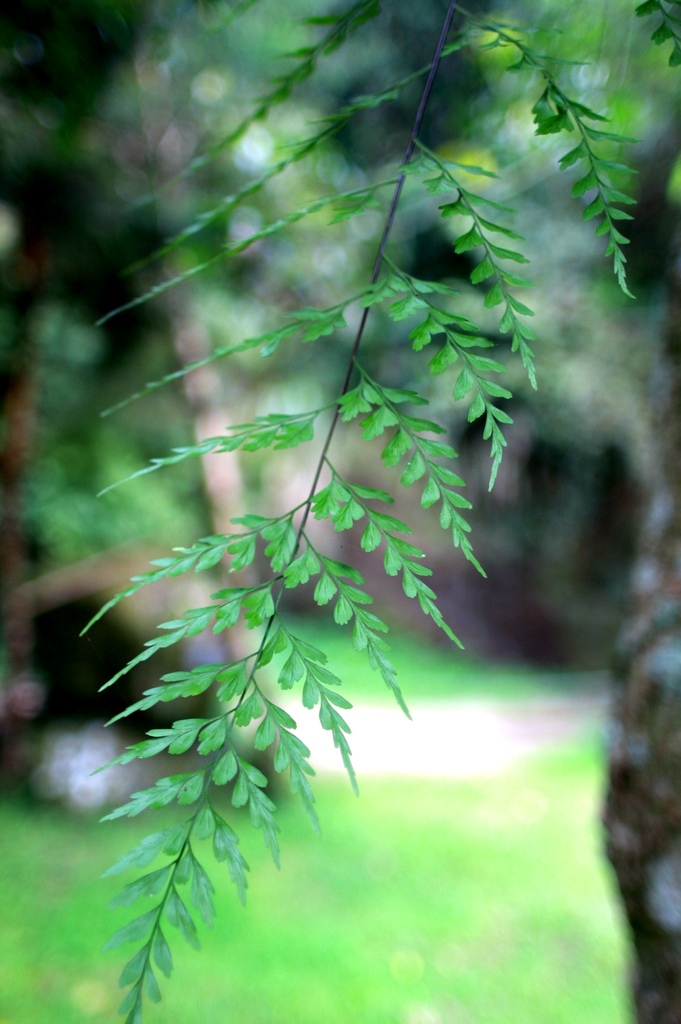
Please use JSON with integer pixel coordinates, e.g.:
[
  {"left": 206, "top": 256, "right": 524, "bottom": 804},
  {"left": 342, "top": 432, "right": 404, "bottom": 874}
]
[{"left": 0, "top": 741, "right": 627, "bottom": 1024}]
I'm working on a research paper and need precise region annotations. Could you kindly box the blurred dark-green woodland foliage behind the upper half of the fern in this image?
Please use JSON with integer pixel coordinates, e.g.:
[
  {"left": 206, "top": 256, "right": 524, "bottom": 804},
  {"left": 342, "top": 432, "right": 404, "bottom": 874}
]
[{"left": 0, "top": 0, "right": 667, "bottom": 685}]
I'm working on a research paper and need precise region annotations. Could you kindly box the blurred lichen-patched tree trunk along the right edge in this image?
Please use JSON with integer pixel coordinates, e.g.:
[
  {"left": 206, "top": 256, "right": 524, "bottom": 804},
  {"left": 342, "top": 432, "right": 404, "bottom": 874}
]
[{"left": 605, "top": 243, "right": 681, "bottom": 1024}]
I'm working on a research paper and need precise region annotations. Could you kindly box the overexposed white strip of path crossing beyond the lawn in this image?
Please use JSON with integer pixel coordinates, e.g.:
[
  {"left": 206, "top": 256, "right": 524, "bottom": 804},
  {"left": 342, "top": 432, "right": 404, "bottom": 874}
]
[{"left": 291, "top": 693, "right": 607, "bottom": 778}]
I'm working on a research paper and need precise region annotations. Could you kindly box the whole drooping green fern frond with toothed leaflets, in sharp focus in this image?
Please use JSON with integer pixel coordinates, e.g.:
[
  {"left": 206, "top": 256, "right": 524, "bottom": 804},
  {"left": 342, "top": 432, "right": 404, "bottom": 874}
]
[{"left": 93, "top": 0, "right": 643, "bottom": 1024}]
